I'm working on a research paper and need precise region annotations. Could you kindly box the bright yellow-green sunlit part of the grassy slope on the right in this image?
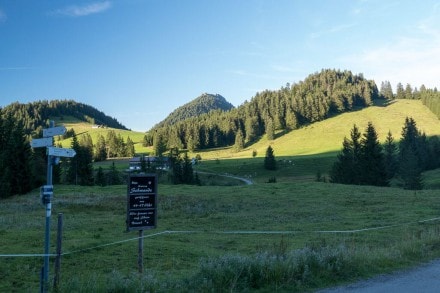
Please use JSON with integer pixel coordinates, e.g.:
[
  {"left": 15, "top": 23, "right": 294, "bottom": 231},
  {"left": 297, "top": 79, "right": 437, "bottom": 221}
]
[{"left": 197, "top": 100, "right": 440, "bottom": 159}]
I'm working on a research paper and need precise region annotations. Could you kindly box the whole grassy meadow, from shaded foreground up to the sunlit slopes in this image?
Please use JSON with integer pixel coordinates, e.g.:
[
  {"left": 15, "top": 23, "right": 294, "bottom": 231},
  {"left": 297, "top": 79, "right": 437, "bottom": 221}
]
[{"left": 0, "top": 100, "right": 440, "bottom": 292}]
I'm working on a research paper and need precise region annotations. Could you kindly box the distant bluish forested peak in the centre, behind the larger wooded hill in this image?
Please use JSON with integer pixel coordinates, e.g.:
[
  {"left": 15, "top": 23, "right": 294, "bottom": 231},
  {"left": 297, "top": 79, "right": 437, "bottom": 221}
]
[{"left": 153, "top": 93, "right": 234, "bottom": 129}]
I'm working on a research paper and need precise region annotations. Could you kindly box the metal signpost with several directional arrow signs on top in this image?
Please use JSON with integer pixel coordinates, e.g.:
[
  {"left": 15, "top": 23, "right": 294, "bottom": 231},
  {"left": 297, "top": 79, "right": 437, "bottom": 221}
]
[{"left": 31, "top": 121, "right": 76, "bottom": 292}]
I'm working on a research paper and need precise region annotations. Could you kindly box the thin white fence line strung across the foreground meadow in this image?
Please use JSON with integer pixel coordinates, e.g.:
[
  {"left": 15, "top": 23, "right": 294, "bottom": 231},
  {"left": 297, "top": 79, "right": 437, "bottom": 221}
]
[{"left": 0, "top": 217, "right": 440, "bottom": 257}]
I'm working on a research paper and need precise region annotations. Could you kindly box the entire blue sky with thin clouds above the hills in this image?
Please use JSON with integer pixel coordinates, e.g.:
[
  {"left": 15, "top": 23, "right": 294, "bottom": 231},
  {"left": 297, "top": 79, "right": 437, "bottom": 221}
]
[{"left": 0, "top": 0, "right": 440, "bottom": 131}]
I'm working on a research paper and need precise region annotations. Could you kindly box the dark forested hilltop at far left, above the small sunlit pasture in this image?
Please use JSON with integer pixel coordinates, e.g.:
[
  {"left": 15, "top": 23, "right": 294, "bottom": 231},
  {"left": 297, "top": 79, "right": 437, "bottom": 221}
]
[{"left": 1, "top": 100, "right": 127, "bottom": 135}]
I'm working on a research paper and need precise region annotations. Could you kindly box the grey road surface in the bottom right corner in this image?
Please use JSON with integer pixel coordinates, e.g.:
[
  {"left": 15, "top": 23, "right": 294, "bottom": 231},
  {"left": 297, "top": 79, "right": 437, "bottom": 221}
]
[{"left": 318, "top": 259, "right": 440, "bottom": 293}]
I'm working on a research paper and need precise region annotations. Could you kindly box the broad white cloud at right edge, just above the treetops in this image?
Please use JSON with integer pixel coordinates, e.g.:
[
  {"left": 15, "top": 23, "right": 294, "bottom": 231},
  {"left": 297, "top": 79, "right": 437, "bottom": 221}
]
[{"left": 340, "top": 13, "right": 440, "bottom": 87}]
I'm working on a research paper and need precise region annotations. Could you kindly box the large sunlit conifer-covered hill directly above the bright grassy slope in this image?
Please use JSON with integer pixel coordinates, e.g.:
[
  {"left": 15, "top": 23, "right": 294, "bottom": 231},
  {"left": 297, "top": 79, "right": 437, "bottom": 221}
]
[{"left": 145, "top": 70, "right": 379, "bottom": 150}]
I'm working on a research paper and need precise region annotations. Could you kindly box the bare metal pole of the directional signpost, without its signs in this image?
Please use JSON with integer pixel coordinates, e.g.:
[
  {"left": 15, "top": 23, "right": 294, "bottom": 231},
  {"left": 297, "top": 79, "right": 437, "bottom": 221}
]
[{"left": 43, "top": 121, "right": 55, "bottom": 292}]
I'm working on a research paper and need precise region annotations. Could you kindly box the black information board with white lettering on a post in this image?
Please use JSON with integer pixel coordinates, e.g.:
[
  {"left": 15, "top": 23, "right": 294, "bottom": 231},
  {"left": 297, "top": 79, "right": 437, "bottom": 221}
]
[{"left": 127, "top": 174, "right": 157, "bottom": 231}]
